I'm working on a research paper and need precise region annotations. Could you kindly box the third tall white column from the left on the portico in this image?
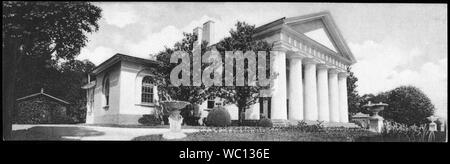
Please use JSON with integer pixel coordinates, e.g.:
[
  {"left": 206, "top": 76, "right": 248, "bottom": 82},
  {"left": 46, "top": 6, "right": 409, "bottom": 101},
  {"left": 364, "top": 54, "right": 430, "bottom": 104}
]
[{"left": 303, "top": 59, "right": 319, "bottom": 121}]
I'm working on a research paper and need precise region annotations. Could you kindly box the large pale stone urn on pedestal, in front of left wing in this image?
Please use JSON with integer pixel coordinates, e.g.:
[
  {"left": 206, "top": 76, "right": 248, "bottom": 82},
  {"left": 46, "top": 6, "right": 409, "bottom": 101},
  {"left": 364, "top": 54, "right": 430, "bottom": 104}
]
[{"left": 161, "top": 101, "right": 189, "bottom": 139}]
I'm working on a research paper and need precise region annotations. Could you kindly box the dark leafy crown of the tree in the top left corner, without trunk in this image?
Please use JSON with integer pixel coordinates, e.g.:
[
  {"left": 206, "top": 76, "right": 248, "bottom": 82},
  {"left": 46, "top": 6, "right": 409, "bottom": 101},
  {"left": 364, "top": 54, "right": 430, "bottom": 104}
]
[{"left": 3, "top": 1, "right": 101, "bottom": 60}]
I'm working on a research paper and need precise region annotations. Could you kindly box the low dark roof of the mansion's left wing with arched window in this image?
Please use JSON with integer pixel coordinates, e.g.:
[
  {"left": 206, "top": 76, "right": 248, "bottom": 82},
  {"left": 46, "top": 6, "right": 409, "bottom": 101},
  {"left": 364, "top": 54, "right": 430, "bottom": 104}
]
[{"left": 92, "top": 53, "right": 161, "bottom": 75}]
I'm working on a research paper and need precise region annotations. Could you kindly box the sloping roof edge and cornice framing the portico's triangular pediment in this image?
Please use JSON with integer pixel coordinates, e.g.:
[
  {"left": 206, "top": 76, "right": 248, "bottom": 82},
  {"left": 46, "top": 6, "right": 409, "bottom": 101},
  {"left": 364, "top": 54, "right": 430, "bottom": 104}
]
[{"left": 254, "top": 11, "right": 356, "bottom": 64}]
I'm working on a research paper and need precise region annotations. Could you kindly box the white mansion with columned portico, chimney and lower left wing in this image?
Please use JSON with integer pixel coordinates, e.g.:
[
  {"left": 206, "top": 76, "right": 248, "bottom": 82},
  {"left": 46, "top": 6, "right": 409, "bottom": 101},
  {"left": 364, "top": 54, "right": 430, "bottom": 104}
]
[{"left": 83, "top": 12, "right": 356, "bottom": 124}]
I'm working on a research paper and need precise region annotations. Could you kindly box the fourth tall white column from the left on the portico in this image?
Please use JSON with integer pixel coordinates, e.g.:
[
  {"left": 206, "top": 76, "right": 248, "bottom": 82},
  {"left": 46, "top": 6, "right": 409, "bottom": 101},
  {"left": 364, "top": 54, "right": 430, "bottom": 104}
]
[{"left": 317, "top": 64, "right": 330, "bottom": 121}]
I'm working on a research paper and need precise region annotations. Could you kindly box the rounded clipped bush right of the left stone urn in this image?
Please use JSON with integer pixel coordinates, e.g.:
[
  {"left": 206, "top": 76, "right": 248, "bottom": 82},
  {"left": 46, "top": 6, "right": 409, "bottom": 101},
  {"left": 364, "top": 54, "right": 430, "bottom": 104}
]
[{"left": 206, "top": 107, "right": 231, "bottom": 126}]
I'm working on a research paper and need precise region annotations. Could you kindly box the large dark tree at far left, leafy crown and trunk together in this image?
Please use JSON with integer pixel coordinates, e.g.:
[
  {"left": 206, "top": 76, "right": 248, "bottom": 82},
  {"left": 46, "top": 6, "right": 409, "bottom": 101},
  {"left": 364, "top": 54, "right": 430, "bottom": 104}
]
[{"left": 2, "top": 1, "right": 101, "bottom": 139}]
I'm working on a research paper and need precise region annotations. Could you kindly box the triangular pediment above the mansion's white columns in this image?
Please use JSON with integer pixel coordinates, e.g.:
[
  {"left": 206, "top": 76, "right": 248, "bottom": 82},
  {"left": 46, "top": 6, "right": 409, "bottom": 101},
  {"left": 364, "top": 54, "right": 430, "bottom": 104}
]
[{"left": 285, "top": 12, "right": 355, "bottom": 63}]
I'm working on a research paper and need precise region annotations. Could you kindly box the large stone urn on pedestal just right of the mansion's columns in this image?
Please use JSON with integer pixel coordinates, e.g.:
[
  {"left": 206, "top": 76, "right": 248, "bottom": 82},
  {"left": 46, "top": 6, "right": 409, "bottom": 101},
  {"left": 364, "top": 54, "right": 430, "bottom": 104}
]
[{"left": 363, "top": 101, "right": 388, "bottom": 133}]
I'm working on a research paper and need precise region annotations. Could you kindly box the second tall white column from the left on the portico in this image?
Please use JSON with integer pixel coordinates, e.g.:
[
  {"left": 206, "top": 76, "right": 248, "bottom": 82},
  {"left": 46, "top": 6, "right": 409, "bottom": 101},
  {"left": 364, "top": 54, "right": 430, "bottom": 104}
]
[{"left": 289, "top": 57, "right": 303, "bottom": 120}]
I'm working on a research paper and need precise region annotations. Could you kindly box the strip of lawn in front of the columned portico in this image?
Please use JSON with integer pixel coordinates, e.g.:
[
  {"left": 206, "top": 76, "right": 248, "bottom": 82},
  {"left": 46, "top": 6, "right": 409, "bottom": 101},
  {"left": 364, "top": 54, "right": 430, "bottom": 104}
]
[{"left": 133, "top": 127, "right": 376, "bottom": 142}]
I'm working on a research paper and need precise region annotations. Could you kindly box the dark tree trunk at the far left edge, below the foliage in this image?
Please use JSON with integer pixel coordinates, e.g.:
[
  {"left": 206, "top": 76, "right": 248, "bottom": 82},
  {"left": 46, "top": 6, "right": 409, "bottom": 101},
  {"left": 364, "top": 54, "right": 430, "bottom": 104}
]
[{"left": 2, "top": 39, "right": 18, "bottom": 140}]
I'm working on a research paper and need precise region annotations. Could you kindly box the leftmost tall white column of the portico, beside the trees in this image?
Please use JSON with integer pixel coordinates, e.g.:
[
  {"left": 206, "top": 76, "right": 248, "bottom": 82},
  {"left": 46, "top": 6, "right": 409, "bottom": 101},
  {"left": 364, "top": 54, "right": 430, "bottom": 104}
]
[{"left": 271, "top": 51, "right": 287, "bottom": 120}]
